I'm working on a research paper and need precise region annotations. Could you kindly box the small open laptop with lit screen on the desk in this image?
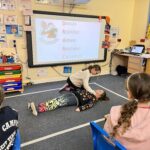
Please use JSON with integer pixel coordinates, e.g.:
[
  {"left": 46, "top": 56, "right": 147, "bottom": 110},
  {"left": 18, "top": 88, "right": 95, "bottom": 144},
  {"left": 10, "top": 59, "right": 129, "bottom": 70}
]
[{"left": 130, "top": 45, "right": 145, "bottom": 54}]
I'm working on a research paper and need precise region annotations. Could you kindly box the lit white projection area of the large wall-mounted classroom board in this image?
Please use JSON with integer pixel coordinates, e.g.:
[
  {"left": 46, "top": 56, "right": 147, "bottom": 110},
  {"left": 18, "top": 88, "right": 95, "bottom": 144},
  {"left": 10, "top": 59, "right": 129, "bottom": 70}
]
[{"left": 31, "top": 11, "right": 105, "bottom": 65}]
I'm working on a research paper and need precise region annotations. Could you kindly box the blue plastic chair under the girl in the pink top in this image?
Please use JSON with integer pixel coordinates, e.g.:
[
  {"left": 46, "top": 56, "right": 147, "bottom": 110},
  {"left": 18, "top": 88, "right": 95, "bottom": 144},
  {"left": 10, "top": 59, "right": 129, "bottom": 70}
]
[{"left": 90, "top": 122, "right": 126, "bottom": 150}]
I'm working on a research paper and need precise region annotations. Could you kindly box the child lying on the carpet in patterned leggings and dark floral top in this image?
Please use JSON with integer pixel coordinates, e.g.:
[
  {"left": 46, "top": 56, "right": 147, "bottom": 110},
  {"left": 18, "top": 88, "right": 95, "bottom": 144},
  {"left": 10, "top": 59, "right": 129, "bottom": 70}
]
[{"left": 28, "top": 89, "right": 109, "bottom": 116}]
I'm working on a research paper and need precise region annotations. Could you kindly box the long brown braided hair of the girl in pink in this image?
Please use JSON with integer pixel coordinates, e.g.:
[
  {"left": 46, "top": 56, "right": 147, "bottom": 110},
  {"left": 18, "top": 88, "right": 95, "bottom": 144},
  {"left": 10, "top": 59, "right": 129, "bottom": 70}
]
[{"left": 112, "top": 73, "right": 150, "bottom": 136}]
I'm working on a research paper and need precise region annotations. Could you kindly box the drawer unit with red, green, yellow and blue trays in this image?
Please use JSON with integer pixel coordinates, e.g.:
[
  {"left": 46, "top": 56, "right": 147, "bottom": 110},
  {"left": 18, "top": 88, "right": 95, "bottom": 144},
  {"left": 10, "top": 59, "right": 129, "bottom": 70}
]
[{"left": 0, "top": 64, "right": 23, "bottom": 93}]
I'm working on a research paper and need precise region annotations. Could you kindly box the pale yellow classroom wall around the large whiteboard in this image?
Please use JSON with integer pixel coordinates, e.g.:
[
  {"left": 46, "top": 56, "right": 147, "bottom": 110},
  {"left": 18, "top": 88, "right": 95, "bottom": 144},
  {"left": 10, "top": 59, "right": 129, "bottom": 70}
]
[{"left": 0, "top": 0, "right": 149, "bottom": 84}]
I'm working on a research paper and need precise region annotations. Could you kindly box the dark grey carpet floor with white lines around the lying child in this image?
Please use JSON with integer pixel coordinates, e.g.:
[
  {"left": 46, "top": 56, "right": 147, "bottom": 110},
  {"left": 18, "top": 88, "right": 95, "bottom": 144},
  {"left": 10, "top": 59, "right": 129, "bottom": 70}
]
[{"left": 5, "top": 75, "right": 126, "bottom": 150}]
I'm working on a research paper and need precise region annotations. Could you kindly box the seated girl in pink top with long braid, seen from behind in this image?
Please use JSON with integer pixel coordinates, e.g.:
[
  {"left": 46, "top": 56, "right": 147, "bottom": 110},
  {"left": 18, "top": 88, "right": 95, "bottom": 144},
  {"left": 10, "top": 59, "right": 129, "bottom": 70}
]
[{"left": 104, "top": 73, "right": 150, "bottom": 150}]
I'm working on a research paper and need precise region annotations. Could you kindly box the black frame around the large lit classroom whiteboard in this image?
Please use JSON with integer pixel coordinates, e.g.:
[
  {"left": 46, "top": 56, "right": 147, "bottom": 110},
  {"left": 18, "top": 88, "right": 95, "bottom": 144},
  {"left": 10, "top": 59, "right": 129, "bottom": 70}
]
[{"left": 26, "top": 10, "right": 107, "bottom": 68}]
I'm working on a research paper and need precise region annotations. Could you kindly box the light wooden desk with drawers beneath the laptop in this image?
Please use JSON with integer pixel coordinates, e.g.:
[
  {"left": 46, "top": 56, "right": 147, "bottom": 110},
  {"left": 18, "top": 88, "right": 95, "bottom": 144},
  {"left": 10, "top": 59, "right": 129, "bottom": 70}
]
[{"left": 110, "top": 52, "right": 150, "bottom": 74}]
